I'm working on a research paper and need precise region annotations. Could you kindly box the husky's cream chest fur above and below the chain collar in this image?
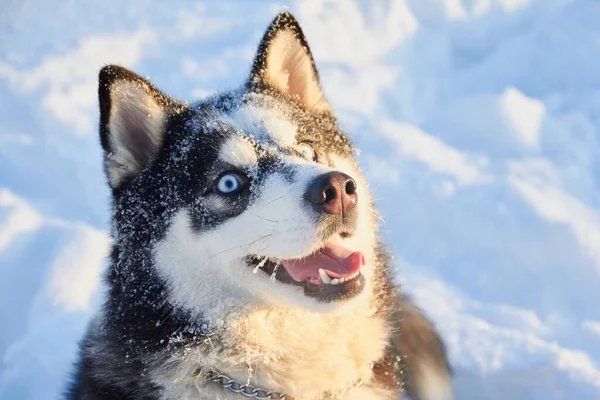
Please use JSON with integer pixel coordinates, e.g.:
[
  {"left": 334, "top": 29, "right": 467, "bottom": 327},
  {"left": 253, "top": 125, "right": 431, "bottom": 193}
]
[{"left": 155, "top": 308, "right": 390, "bottom": 400}]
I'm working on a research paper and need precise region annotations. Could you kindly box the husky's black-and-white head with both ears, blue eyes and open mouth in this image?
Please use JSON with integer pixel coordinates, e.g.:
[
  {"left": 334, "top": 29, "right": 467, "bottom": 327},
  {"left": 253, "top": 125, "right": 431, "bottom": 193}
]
[{"left": 100, "top": 13, "right": 375, "bottom": 312}]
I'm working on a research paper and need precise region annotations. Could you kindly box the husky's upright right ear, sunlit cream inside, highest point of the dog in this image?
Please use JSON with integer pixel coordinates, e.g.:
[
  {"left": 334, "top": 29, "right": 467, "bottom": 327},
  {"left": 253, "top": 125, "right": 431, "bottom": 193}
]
[{"left": 249, "top": 12, "right": 331, "bottom": 113}]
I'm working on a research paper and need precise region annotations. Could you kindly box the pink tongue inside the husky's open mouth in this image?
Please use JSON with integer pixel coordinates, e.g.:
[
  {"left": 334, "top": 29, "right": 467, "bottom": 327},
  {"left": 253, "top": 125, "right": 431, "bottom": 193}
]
[{"left": 281, "top": 244, "right": 365, "bottom": 282}]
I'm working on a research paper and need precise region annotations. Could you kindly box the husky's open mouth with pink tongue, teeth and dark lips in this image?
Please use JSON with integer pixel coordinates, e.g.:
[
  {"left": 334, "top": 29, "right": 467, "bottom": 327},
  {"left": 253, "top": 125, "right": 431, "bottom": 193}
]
[{"left": 246, "top": 243, "right": 365, "bottom": 303}]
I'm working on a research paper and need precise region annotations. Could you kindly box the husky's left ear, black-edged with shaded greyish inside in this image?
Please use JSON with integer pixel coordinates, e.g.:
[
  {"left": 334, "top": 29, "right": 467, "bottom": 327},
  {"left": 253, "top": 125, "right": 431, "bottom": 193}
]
[{"left": 98, "top": 65, "right": 175, "bottom": 189}]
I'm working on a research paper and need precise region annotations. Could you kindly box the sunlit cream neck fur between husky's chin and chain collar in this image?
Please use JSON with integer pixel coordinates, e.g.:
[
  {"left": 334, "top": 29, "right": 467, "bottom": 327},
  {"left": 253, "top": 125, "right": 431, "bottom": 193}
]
[{"left": 195, "top": 296, "right": 388, "bottom": 398}]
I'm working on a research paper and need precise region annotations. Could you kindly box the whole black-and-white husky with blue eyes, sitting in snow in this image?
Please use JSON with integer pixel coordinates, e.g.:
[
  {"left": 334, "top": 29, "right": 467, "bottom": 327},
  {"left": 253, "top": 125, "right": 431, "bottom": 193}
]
[{"left": 68, "top": 12, "right": 452, "bottom": 400}]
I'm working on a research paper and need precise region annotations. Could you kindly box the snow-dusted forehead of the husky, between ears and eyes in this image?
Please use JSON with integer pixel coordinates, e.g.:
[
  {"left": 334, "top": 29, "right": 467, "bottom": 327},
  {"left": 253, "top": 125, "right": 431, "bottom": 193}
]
[{"left": 188, "top": 91, "right": 354, "bottom": 168}]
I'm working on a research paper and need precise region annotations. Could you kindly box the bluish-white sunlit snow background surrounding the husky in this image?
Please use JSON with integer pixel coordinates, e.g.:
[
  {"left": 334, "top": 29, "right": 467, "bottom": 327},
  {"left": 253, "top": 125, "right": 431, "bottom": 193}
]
[{"left": 0, "top": 0, "right": 600, "bottom": 400}]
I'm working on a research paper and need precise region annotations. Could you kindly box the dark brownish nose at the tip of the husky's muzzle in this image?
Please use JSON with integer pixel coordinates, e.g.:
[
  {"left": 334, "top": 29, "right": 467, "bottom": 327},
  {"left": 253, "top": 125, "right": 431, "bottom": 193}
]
[{"left": 306, "top": 172, "right": 358, "bottom": 216}]
